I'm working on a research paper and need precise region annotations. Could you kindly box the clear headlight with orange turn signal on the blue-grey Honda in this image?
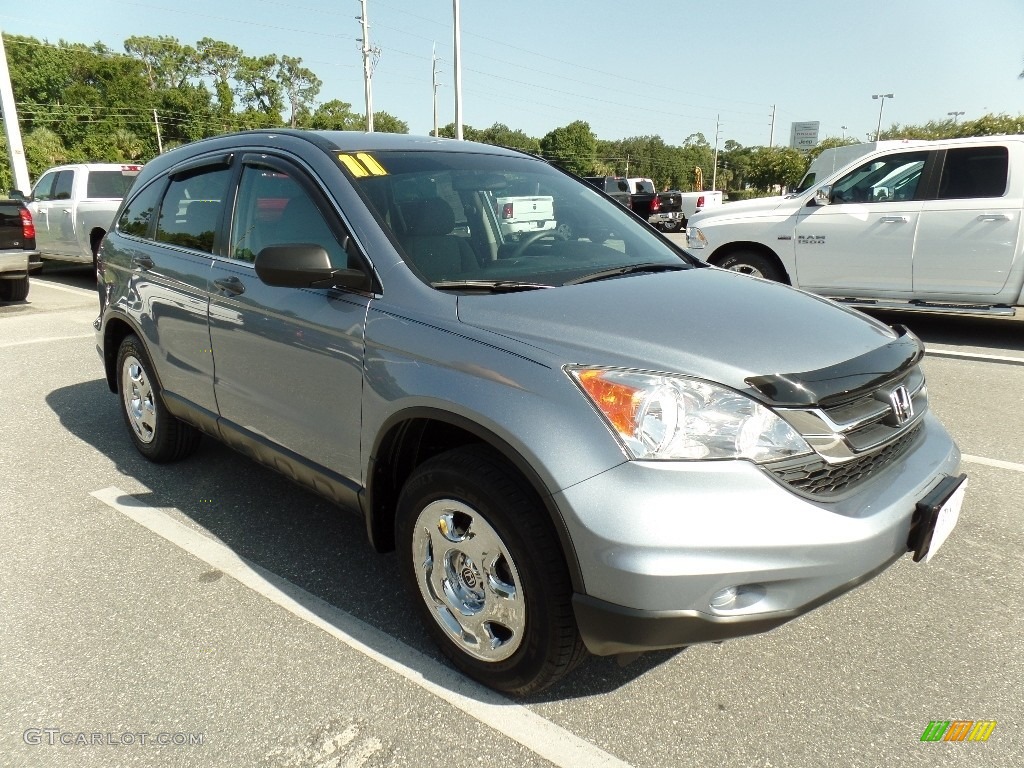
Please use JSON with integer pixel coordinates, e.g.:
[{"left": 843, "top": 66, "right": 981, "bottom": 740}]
[{"left": 568, "top": 368, "right": 811, "bottom": 463}]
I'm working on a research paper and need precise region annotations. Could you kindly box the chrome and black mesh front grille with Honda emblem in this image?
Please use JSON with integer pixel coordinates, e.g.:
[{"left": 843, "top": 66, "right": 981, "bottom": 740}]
[{"left": 765, "top": 367, "right": 928, "bottom": 499}]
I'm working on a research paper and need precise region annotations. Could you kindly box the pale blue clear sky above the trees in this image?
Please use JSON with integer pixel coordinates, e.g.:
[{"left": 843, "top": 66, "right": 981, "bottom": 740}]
[{"left": 0, "top": 0, "right": 1024, "bottom": 145}]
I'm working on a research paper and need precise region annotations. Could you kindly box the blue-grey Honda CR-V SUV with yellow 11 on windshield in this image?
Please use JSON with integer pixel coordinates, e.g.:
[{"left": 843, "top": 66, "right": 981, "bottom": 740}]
[{"left": 96, "top": 130, "right": 966, "bottom": 694}]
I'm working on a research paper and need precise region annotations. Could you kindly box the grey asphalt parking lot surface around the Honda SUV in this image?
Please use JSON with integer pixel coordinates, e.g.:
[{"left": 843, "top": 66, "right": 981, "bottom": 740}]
[{"left": 0, "top": 268, "right": 1024, "bottom": 768}]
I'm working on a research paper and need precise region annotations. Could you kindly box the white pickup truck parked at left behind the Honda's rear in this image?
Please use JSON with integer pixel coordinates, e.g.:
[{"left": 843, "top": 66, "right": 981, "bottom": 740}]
[{"left": 12, "top": 163, "right": 142, "bottom": 264}]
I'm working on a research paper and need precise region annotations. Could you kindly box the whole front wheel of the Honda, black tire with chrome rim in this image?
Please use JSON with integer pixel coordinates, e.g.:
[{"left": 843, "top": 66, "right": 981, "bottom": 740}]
[{"left": 397, "top": 445, "right": 586, "bottom": 695}]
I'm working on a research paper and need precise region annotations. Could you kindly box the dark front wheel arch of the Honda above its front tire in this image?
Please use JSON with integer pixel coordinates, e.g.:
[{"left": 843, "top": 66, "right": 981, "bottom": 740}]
[{"left": 360, "top": 407, "right": 583, "bottom": 592}]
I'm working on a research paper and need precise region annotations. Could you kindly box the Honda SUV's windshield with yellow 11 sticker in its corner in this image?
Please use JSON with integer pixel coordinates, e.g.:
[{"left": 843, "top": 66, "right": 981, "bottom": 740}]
[{"left": 338, "top": 151, "right": 693, "bottom": 290}]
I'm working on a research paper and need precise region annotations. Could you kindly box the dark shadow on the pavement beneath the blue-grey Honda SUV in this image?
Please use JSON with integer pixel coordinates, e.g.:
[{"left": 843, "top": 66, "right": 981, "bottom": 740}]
[{"left": 46, "top": 379, "right": 679, "bottom": 703}]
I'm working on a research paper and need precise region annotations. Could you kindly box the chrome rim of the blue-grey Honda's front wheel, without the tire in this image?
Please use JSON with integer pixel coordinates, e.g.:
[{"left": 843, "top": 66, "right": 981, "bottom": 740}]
[{"left": 412, "top": 499, "right": 526, "bottom": 662}]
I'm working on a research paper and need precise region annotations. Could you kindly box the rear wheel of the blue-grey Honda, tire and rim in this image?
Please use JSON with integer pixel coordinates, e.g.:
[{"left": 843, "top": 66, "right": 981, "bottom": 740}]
[{"left": 118, "top": 335, "right": 200, "bottom": 462}]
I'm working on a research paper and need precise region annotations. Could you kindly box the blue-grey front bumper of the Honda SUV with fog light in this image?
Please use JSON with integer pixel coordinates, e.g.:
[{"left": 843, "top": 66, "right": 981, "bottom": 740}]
[{"left": 555, "top": 414, "right": 959, "bottom": 655}]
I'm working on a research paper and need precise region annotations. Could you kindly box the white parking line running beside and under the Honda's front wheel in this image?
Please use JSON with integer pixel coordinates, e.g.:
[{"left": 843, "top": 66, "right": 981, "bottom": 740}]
[{"left": 92, "top": 486, "right": 631, "bottom": 768}]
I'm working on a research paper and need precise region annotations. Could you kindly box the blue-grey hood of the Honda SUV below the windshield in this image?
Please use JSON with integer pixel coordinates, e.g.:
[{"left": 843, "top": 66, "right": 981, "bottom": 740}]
[{"left": 459, "top": 268, "right": 906, "bottom": 399}]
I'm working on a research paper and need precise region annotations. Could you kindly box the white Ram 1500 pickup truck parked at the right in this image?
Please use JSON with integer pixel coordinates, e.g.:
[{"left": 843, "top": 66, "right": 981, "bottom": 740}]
[{"left": 686, "top": 135, "right": 1024, "bottom": 314}]
